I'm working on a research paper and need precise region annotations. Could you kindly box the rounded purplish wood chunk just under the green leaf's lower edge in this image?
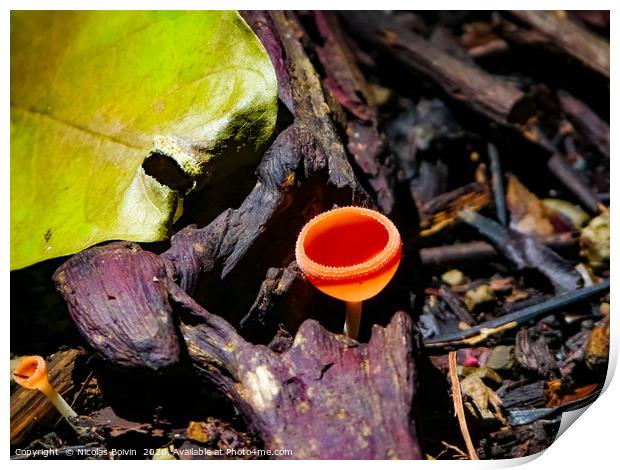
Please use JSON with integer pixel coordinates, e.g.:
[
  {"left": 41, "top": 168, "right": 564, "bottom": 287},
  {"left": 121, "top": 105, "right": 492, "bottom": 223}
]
[{"left": 54, "top": 242, "right": 180, "bottom": 370}]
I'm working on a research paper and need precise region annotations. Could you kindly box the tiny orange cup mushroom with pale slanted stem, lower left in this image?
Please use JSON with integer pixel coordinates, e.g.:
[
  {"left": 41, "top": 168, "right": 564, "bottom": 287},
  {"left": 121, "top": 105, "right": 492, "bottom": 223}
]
[{"left": 13, "top": 356, "right": 77, "bottom": 430}]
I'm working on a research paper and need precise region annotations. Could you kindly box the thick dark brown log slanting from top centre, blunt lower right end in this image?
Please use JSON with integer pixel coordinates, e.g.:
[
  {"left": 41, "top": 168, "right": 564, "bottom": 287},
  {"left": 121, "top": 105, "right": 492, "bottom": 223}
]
[{"left": 342, "top": 11, "right": 533, "bottom": 124}]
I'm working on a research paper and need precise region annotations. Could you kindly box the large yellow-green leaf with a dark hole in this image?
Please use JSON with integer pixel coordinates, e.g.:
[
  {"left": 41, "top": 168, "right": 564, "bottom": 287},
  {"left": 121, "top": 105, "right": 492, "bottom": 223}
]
[{"left": 11, "top": 11, "right": 277, "bottom": 269}]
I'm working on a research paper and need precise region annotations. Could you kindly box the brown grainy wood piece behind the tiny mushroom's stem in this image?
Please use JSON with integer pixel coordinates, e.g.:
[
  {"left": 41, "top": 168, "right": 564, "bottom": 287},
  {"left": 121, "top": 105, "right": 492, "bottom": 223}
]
[{"left": 11, "top": 349, "right": 85, "bottom": 445}]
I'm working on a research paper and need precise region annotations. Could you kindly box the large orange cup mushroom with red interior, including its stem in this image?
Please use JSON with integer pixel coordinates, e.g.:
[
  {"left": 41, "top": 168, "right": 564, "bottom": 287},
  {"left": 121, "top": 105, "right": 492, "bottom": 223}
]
[{"left": 295, "top": 207, "right": 402, "bottom": 338}]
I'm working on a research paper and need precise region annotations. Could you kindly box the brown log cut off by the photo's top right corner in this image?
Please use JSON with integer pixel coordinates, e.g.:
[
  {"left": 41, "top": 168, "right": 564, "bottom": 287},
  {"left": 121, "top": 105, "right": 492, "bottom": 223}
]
[{"left": 512, "top": 10, "right": 610, "bottom": 78}]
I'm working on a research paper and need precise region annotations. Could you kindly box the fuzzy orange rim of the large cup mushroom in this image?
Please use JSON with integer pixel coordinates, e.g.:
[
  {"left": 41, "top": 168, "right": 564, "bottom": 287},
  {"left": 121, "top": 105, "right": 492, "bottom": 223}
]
[{"left": 295, "top": 206, "right": 402, "bottom": 281}]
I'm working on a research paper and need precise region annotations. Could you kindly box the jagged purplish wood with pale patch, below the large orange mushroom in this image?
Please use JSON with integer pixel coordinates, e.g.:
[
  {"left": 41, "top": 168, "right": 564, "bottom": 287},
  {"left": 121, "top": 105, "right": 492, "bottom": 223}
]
[{"left": 170, "top": 280, "right": 421, "bottom": 459}]
